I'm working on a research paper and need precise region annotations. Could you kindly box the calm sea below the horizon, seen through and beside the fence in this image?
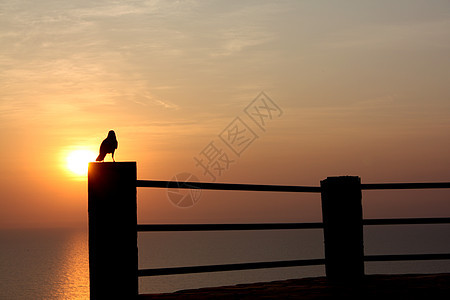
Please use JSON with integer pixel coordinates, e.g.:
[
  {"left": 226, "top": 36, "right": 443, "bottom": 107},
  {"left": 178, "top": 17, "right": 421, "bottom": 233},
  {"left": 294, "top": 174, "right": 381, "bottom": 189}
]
[{"left": 0, "top": 225, "right": 450, "bottom": 299}]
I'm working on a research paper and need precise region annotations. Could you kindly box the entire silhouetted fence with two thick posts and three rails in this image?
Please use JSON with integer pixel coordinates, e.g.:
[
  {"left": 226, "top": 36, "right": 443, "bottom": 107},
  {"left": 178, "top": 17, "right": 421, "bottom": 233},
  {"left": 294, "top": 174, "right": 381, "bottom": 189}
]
[{"left": 88, "top": 162, "right": 450, "bottom": 299}]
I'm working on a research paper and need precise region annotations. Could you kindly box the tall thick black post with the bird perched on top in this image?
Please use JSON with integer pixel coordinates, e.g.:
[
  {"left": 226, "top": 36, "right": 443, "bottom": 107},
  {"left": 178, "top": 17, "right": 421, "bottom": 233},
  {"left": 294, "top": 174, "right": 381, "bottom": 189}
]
[{"left": 88, "top": 162, "right": 138, "bottom": 299}]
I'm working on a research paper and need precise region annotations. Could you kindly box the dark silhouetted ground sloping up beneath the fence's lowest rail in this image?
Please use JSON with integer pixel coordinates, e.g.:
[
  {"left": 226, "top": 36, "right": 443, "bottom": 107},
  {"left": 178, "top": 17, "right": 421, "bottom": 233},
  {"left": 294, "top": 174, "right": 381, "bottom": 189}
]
[{"left": 138, "top": 273, "right": 450, "bottom": 300}]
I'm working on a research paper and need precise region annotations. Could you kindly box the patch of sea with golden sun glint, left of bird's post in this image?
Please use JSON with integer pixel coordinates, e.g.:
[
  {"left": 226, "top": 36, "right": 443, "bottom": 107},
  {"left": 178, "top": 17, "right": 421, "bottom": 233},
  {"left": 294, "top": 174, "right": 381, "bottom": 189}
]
[{"left": 0, "top": 229, "right": 89, "bottom": 300}]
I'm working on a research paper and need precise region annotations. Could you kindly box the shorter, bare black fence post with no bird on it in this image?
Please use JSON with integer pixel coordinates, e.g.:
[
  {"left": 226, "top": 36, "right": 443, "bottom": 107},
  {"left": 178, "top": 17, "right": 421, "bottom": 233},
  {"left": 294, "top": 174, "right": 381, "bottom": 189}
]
[{"left": 320, "top": 176, "right": 364, "bottom": 282}]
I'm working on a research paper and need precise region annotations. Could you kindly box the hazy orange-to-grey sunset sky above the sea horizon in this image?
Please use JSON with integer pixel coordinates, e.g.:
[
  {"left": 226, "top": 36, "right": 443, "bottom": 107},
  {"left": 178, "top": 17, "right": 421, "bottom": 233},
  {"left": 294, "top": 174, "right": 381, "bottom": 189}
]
[{"left": 0, "top": 0, "right": 450, "bottom": 228}]
